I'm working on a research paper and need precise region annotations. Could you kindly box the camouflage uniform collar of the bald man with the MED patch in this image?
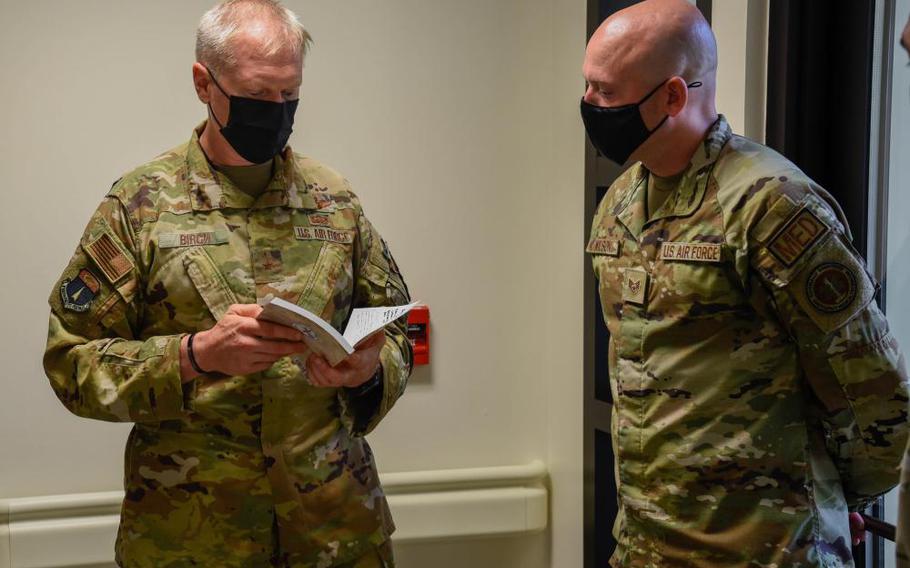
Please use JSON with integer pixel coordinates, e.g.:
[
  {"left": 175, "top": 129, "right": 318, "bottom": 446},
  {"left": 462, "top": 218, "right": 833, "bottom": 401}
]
[{"left": 615, "top": 115, "right": 733, "bottom": 236}]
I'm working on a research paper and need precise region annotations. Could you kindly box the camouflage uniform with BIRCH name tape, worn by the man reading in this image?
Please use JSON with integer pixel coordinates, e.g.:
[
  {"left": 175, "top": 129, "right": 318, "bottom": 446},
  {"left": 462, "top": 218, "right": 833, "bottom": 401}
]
[{"left": 44, "top": 125, "right": 411, "bottom": 568}]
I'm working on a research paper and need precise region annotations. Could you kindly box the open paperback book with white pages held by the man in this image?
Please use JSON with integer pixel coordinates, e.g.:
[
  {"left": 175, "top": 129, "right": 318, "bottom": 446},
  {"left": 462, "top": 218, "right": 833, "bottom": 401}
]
[{"left": 258, "top": 298, "right": 419, "bottom": 367}]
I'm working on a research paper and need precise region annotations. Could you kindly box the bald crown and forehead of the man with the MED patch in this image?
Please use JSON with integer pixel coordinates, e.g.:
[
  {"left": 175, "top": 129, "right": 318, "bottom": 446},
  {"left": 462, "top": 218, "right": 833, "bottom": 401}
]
[{"left": 585, "top": 0, "right": 717, "bottom": 100}]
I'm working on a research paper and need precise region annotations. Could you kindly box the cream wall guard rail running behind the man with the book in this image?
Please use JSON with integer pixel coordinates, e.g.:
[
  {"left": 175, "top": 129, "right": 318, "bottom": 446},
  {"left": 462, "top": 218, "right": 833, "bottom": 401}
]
[{"left": 0, "top": 461, "right": 548, "bottom": 568}]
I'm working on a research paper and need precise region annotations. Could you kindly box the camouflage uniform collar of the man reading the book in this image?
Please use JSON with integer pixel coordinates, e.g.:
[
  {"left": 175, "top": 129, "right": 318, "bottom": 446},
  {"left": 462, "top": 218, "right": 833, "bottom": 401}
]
[{"left": 186, "top": 122, "right": 319, "bottom": 211}]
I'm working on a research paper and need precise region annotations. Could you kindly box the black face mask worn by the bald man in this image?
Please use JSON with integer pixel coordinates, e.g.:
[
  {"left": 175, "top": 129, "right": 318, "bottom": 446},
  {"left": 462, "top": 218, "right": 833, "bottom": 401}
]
[{"left": 581, "top": 81, "right": 702, "bottom": 165}]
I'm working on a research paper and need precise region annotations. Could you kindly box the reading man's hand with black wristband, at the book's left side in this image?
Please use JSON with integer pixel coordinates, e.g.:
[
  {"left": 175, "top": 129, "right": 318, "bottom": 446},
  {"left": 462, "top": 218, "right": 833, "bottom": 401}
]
[{"left": 180, "top": 304, "right": 306, "bottom": 382}]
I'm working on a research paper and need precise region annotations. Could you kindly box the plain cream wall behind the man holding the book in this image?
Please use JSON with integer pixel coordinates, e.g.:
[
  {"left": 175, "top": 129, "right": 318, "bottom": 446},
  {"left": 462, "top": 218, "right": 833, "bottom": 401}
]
[{"left": 0, "top": 0, "right": 585, "bottom": 568}]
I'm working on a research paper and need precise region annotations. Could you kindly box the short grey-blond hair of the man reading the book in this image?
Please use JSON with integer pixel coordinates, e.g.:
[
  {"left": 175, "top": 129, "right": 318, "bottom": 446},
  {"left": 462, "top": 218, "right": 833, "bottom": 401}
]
[{"left": 196, "top": 0, "right": 313, "bottom": 71}]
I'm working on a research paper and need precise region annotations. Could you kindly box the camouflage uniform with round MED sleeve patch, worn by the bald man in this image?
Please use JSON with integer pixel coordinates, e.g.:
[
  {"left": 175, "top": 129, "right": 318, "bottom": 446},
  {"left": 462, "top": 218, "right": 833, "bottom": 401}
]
[{"left": 587, "top": 117, "right": 907, "bottom": 568}]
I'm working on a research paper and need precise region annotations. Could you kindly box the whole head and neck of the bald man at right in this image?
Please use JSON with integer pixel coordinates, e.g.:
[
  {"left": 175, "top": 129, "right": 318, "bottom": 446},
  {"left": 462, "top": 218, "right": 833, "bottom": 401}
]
[{"left": 582, "top": 0, "right": 718, "bottom": 175}]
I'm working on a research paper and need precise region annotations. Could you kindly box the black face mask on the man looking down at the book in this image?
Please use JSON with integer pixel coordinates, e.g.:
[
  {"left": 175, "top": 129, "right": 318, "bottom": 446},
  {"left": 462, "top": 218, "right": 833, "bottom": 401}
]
[{"left": 209, "top": 67, "right": 298, "bottom": 164}]
